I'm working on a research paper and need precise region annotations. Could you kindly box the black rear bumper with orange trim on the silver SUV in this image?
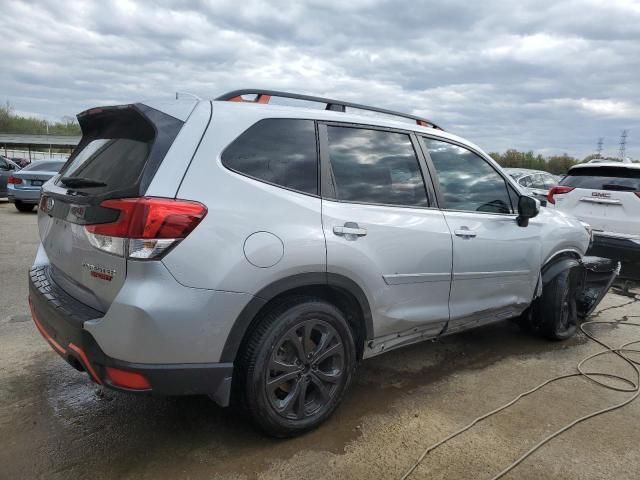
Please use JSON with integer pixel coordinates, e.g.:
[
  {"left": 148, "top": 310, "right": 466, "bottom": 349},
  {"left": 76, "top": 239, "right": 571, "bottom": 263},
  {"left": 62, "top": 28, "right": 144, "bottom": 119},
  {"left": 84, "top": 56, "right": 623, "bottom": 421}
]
[{"left": 29, "top": 266, "right": 233, "bottom": 406}]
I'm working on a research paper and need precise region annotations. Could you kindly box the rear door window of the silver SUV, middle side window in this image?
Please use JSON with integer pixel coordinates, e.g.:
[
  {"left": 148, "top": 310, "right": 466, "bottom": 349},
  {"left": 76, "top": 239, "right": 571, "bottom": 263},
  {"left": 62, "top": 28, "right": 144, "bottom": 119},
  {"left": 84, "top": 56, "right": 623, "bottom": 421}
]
[{"left": 327, "top": 126, "right": 429, "bottom": 207}]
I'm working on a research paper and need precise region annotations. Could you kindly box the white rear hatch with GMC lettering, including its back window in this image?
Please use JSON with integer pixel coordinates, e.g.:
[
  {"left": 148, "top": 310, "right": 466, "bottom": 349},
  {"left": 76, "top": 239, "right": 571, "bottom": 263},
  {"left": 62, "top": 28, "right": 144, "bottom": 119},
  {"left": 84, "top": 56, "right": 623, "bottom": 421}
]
[{"left": 553, "top": 164, "right": 640, "bottom": 235}]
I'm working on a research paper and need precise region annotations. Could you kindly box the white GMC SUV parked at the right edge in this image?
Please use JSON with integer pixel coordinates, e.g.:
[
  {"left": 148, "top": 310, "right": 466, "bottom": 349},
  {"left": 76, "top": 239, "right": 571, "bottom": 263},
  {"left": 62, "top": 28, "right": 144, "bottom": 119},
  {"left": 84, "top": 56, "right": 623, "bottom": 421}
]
[{"left": 548, "top": 162, "right": 640, "bottom": 279}]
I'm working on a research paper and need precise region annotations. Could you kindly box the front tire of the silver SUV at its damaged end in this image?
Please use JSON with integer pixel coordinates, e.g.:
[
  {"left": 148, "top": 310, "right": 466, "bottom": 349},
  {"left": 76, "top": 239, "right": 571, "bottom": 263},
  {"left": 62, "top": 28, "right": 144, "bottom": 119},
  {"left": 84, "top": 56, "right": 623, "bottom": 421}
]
[{"left": 534, "top": 269, "right": 578, "bottom": 340}]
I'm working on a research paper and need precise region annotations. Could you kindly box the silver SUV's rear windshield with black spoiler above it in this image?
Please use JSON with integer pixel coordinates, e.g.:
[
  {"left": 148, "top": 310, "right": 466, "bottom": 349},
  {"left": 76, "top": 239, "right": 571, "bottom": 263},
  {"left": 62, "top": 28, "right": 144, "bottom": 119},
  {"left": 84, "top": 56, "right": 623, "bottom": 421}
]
[{"left": 56, "top": 106, "right": 183, "bottom": 196}]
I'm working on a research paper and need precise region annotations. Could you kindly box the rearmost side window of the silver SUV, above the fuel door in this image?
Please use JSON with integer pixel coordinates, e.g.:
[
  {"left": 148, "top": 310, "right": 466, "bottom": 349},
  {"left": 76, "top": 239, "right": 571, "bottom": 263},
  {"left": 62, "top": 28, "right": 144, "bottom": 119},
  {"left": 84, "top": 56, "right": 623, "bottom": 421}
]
[{"left": 222, "top": 118, "right": 318, "bottom": 195}]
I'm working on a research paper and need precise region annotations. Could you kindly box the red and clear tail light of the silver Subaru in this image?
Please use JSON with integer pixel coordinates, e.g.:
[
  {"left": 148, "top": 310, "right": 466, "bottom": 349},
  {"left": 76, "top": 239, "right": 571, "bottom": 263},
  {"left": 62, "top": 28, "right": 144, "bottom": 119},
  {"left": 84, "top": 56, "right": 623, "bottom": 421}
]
[{"left": 84, "top": 197, "right": 207, "bottom": 260}]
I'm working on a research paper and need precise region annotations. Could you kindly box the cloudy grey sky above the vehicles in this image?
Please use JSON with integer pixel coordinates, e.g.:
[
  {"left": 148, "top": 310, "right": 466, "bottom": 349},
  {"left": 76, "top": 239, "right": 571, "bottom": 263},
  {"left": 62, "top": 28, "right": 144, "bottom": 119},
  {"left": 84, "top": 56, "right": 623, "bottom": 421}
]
[{"left": 0, "top": 0, "right": 640, "bottom": 158}]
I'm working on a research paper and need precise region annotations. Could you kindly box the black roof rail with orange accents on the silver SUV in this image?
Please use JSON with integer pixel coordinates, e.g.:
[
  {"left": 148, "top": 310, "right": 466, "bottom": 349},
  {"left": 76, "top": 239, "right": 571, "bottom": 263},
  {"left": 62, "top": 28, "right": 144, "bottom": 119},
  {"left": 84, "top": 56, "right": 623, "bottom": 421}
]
[{"left": 215, "top": 88, "right": 443, "bottom": 130}]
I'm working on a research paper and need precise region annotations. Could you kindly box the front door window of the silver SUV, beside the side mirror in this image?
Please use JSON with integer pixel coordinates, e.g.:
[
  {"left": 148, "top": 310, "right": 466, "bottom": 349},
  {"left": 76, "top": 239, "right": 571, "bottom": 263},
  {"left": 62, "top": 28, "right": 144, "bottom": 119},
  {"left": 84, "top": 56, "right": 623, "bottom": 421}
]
[{"left": 423, "top": 138, "right": 512, "bottom": 213}]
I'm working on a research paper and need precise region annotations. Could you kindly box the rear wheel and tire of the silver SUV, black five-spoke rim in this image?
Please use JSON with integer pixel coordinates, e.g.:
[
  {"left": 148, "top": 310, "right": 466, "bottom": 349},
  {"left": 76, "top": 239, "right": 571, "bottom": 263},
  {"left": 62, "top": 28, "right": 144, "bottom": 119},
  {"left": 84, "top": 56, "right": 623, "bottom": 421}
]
[{"left": 237, "top": 297, "right": 356, "bottom": 437}]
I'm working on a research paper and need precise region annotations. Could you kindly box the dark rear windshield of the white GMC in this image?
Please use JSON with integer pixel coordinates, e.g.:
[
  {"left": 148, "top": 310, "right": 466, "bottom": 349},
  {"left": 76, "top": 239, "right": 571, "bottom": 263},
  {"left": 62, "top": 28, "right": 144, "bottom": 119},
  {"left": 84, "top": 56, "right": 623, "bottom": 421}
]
[{"left": 560, "top": 167, "right": 640, "bottom": 192}]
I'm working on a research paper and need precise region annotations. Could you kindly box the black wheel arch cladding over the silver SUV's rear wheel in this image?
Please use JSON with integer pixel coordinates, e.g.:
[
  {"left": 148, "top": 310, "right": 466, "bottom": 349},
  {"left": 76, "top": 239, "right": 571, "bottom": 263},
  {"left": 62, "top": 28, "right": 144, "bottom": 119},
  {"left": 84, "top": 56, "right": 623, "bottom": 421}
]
[{"left": 220, "top": 272, "right": 374, "bottom": 362}]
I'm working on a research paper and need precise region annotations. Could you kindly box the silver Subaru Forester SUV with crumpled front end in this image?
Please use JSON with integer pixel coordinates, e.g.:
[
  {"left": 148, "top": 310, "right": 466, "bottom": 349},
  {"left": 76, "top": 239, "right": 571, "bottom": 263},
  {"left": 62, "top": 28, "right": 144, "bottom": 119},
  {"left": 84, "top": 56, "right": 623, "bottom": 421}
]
[{"left": 29, "top": 90, "right": 615, "bottom": 436}]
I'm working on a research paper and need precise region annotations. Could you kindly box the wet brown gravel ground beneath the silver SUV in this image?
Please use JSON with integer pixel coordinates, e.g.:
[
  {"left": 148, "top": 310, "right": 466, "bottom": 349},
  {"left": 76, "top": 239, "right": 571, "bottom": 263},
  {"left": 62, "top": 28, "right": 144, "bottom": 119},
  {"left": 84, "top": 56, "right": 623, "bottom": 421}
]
[{"left": 0, "top": 200, "right": 640, "bottom": 480}]
